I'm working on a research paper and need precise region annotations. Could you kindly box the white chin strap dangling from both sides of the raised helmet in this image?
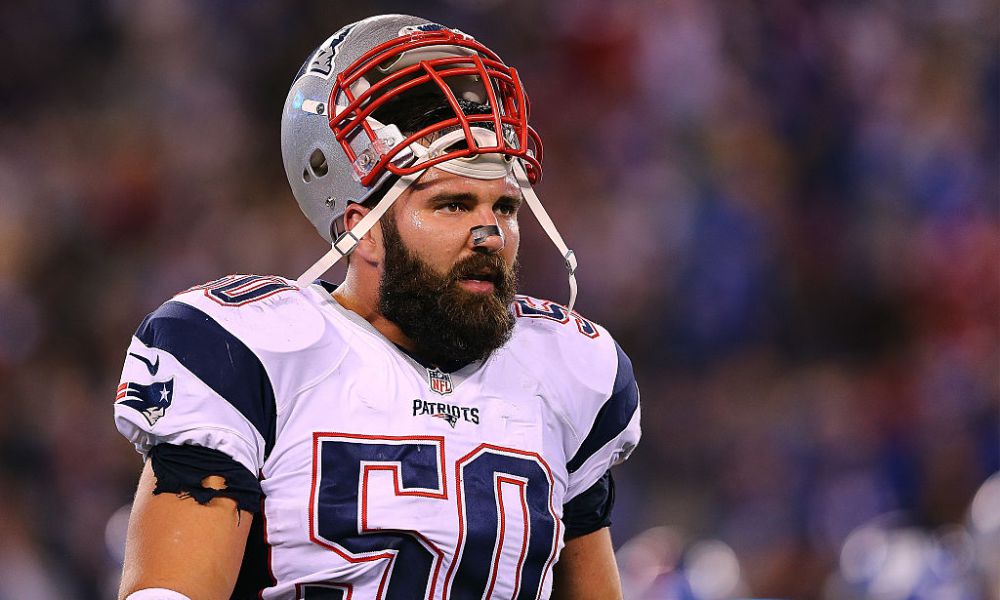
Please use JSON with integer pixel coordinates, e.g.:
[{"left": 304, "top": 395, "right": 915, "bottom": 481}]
[{"left": 297, "top": 127, "right": 576, "bottom": 310}]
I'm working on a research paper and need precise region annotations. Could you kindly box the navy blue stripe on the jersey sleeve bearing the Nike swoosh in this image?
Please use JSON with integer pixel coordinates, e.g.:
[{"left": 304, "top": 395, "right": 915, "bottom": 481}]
[{"left": 135, "top": 302, "right": 276, "bottom": 458}]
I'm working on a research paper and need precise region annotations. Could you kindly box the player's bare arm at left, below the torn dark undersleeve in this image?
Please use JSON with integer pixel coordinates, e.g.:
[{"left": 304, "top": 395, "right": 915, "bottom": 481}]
[{"left": 118, "top": 461, "right": 253, "bottom": 600}]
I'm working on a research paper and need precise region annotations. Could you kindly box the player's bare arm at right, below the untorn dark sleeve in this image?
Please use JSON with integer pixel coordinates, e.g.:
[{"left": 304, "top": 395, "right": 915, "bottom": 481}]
[{"left": 552, "top": 527, "right": 622, "bottom": 600}]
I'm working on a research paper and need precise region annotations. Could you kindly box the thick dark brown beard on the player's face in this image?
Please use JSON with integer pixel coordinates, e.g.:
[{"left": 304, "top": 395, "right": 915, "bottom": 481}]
[{"left": 379, "top": 214, "right": 518, "bottom": 371}]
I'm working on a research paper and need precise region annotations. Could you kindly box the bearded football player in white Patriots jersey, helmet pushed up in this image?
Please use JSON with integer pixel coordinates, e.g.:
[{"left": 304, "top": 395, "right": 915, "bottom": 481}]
[{"left": 115, "top": 15, "right": 639, "bottom": 600}]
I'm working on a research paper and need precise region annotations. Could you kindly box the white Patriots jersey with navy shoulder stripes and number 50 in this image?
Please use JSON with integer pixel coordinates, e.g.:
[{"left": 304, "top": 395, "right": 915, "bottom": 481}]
[{"left": 115, "top": 275, "right": 639, "bottom": 600}]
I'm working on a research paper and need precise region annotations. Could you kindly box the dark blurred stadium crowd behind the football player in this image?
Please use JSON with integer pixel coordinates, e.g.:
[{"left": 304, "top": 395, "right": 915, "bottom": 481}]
[{"left": 0, "top": 0, "right": 1000, "bottom": 600}]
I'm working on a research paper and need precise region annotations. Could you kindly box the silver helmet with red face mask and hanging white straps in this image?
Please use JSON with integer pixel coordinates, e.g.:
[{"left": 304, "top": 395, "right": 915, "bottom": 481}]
[{"left": 281, "top": 15, "right": 576, "bottom": 308}]
